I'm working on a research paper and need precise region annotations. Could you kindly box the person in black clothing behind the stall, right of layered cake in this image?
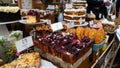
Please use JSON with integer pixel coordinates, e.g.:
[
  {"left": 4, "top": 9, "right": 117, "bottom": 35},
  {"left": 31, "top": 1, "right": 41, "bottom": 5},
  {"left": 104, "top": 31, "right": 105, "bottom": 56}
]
[{"left": 87, "top": 0, "right": 111, "bottom": 20}]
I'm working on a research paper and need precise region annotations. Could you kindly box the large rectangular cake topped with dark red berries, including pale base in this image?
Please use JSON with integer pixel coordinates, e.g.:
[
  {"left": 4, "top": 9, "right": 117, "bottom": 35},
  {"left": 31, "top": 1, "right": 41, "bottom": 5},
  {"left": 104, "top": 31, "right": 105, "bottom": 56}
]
[{"left": 34, "top": 32, "right": 93, "bottom": 68}]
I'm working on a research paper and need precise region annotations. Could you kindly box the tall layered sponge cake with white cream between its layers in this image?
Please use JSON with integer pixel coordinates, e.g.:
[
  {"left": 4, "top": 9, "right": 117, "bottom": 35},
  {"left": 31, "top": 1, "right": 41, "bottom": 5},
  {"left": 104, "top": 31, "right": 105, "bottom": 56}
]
[{"left": 64, "top": 7, "right": 86, "bottom": 25}]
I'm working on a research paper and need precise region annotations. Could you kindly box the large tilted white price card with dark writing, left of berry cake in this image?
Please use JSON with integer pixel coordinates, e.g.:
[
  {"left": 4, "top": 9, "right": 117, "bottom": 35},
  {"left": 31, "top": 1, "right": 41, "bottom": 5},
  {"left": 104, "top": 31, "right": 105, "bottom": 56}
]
[{"left": 16, "top": 36, "right": 33, "bottom": 53}]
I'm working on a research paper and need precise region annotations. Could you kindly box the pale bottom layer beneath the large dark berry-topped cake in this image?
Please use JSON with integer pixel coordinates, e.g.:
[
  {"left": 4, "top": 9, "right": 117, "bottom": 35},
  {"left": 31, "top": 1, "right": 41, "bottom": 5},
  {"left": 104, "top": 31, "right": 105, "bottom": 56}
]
[{"left": 36, "top": 48, "right": 92, "bottom": 68}]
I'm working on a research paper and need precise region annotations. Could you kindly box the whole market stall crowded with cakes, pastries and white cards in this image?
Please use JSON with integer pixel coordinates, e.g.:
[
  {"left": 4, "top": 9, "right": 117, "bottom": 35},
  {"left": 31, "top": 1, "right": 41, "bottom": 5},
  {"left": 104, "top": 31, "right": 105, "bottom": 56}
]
[{"left": 0, "top": 0, "right": 120, "bottom": 68}]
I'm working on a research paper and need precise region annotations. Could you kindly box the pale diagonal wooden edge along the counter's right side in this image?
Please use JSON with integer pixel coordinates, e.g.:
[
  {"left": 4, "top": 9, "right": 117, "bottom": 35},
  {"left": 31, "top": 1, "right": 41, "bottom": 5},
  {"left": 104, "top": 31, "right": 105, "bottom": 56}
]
[{"left": 91, "top": 37, "right": 115, "bottom": 68}]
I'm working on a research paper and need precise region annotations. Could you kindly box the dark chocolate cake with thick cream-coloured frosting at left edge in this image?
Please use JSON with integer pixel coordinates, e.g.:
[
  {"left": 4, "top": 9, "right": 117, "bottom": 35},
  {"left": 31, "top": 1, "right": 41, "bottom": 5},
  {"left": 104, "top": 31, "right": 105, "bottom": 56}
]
[{"left": 0, "top": 6, "right": 21, "bottom": 22}]
